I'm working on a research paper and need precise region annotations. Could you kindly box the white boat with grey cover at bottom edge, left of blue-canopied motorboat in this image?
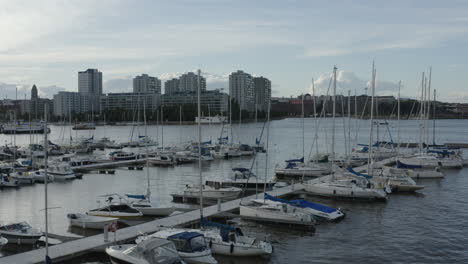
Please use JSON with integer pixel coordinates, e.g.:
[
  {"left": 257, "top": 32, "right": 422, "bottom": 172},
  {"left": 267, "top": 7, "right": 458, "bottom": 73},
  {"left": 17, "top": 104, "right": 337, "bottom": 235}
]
[{"left": 106, "top": 237, "right": 184, "bottom": 264}]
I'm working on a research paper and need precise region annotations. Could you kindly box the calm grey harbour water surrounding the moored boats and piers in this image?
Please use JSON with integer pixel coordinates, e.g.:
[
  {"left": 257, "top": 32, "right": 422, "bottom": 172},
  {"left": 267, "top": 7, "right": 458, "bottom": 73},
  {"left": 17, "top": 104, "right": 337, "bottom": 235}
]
[{"left": 0, "top": 119, "right": 468, "bottom": 263}]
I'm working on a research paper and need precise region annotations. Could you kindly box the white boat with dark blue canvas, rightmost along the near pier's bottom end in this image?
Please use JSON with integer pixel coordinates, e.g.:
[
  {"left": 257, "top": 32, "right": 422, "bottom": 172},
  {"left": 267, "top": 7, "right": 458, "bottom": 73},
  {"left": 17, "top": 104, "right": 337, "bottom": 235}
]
[{"left": 199, "top": 219, "right": 273, "bottom": 257}]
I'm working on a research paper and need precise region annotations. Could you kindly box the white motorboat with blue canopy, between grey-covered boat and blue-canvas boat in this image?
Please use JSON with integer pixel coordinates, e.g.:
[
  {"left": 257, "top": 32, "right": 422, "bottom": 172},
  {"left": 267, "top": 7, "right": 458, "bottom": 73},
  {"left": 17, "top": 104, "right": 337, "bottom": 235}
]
[{"left": 136, "top": 228, "right": 218, "bottom": 264}]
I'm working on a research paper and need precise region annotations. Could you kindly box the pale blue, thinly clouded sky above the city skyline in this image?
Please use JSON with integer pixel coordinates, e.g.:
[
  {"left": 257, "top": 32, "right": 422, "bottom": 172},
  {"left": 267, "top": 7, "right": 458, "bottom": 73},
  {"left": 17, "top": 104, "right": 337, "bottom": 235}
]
[{"left": 0, "top": 0, "right": 468, "bottom": 103}]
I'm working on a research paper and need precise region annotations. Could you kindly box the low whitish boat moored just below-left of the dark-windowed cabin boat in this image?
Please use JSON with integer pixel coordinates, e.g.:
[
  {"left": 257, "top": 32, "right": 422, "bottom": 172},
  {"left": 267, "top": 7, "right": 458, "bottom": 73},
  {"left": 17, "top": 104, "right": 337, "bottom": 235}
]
[{"left": 184, "top": 184, "right": 242, "bottom": 200}]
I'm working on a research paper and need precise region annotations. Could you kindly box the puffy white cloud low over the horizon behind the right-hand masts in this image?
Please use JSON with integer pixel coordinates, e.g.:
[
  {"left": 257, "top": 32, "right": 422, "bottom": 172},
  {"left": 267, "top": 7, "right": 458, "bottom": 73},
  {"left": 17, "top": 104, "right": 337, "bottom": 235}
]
[{"left": 310, "top": 71, "right": 398, "bottom": 95}]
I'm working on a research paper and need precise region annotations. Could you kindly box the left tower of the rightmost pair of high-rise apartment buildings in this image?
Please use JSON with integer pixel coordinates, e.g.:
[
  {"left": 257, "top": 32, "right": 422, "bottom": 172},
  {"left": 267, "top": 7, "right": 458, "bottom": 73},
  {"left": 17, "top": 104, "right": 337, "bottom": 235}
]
[{"left": 229, "top": 70, "right": 255, "bottom": 111}]
